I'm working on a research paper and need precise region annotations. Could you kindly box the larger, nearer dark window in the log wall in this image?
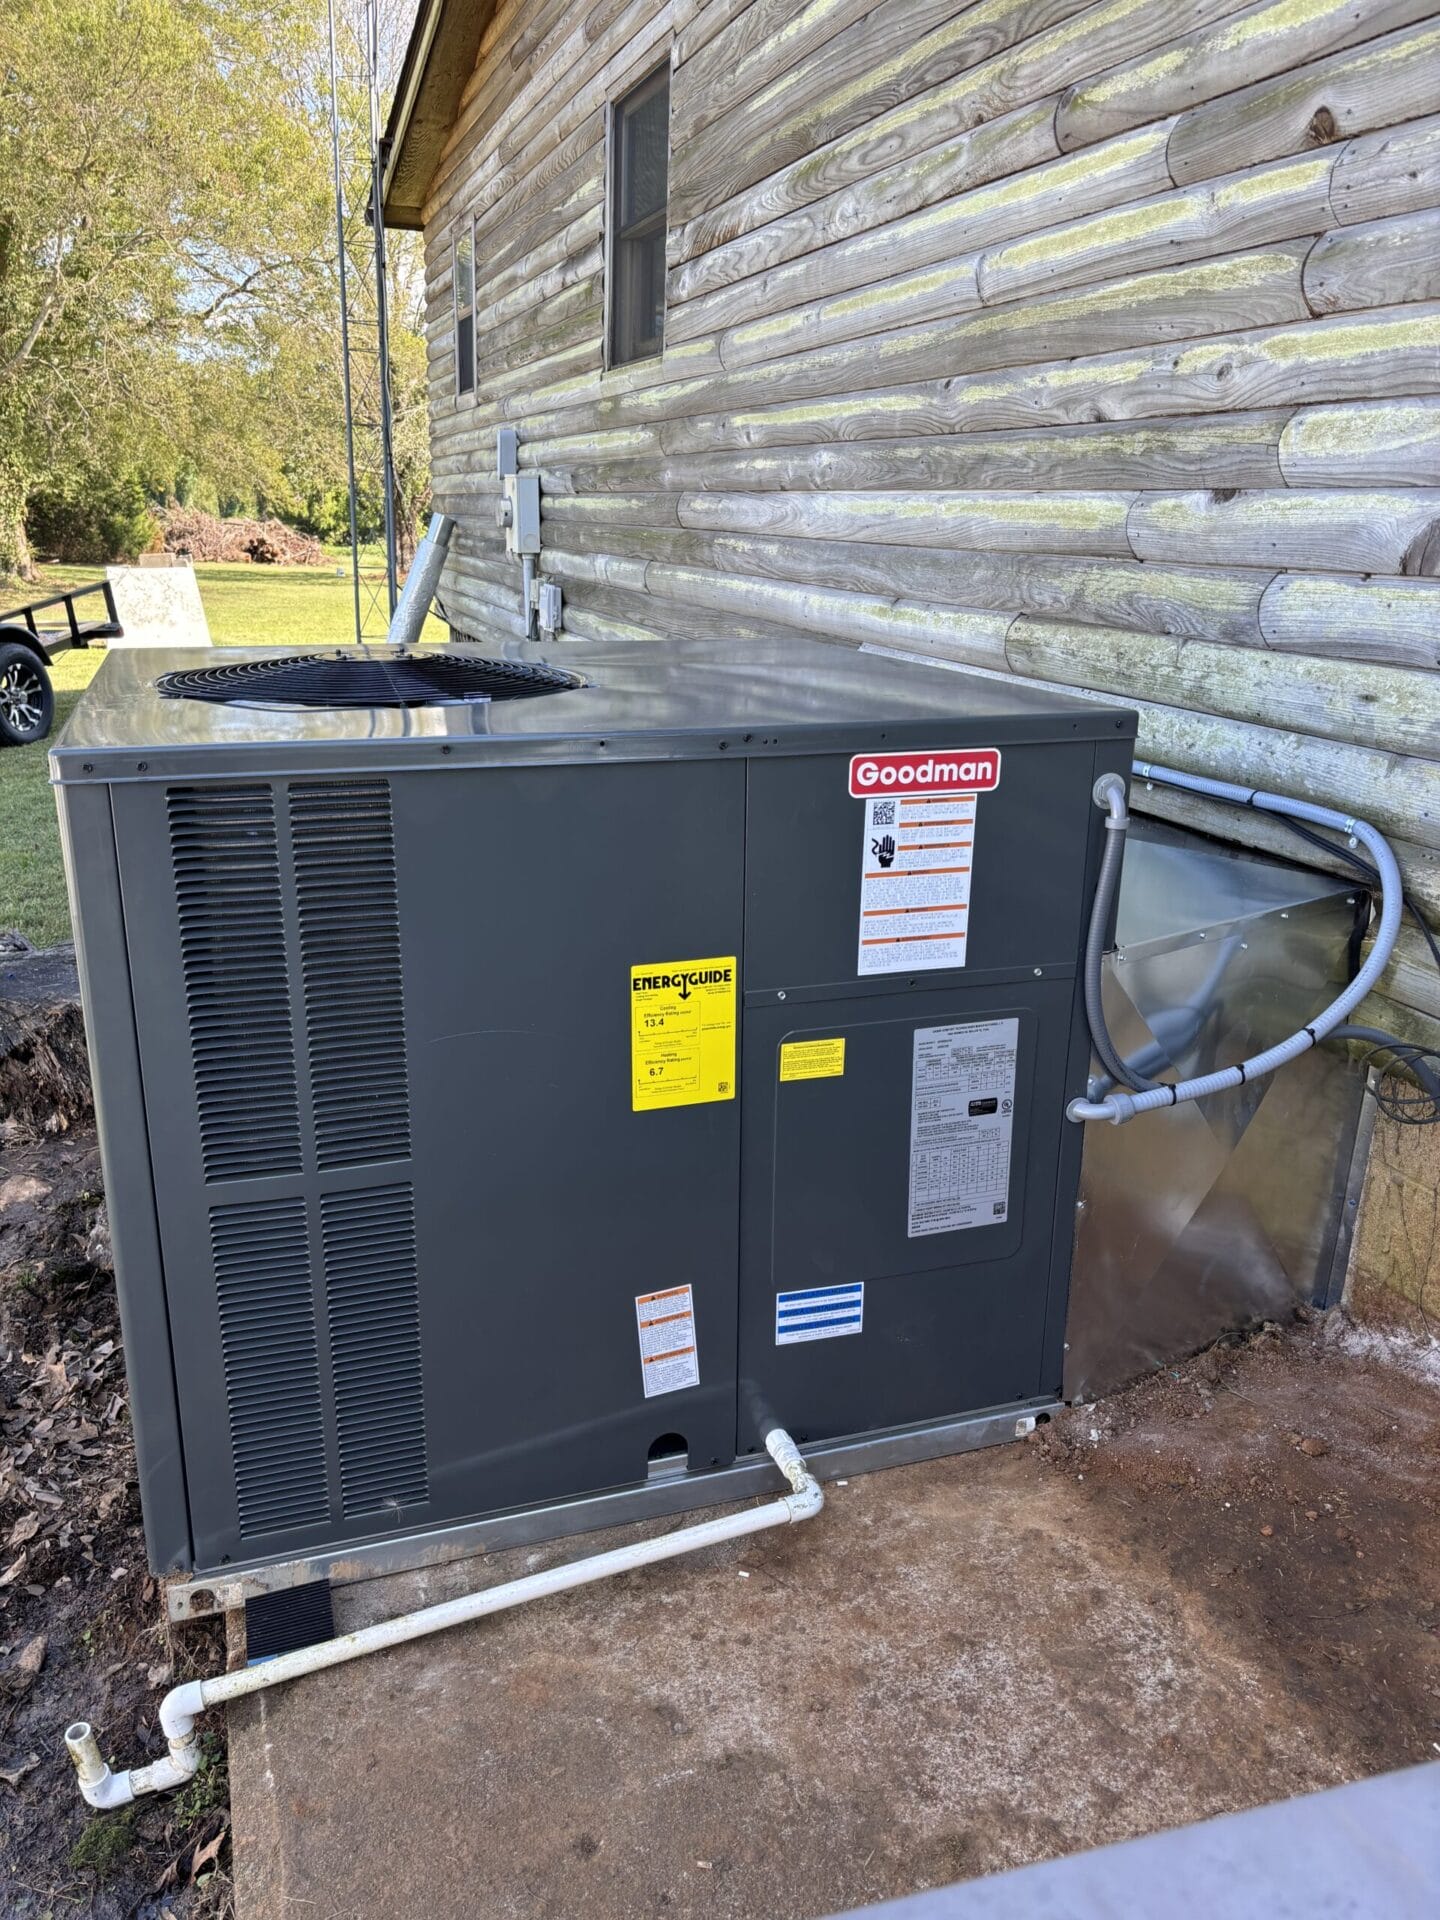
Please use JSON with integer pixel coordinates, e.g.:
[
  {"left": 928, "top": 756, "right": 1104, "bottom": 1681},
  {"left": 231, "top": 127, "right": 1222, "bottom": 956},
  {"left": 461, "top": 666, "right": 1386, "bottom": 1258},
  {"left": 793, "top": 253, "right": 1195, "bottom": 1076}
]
[{"left": 609, "top": 65, "right": 670, "bottom": 367}]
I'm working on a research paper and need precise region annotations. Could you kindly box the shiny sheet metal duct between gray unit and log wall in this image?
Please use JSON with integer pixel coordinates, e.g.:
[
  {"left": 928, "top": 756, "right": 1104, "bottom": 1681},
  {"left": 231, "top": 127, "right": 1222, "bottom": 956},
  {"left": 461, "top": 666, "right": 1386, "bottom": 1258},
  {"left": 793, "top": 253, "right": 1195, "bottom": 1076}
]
[{"left": 1066, "top": 824, "right": 1365, "bottom": 1400}]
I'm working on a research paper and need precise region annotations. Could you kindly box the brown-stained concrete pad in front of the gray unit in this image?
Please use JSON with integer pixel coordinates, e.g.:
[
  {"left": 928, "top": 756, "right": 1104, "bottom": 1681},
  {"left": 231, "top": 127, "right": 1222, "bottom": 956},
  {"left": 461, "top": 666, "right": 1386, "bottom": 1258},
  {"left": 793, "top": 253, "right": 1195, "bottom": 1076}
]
[{"left": 230, "top": 1331, "right": 1440, "bottom": 1920}]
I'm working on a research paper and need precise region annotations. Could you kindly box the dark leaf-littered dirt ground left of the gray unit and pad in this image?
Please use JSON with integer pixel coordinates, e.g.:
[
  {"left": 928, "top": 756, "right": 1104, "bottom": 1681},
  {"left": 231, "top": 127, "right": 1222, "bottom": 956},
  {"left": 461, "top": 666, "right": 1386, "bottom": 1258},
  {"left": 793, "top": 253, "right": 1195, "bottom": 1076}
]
[{"left": 0, "top": 1129, "right": 228, "bottom": 1920}]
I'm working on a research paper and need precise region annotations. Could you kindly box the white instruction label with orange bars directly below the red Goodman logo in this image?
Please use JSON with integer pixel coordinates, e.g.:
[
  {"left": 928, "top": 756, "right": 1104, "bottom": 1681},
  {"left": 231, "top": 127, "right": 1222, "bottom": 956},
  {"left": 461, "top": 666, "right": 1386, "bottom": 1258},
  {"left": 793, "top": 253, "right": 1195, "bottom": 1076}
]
[{"left": 856, "top": 793, "right": 975, "bottom": 975}]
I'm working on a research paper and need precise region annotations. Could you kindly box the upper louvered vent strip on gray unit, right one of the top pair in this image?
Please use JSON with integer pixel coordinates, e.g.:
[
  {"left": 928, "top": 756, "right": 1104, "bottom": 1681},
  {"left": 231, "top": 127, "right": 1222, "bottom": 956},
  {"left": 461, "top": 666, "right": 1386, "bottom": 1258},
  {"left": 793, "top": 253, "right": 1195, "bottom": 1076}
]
[{"left": 290, "top": 780, "right": 411, "bottom": 1167}]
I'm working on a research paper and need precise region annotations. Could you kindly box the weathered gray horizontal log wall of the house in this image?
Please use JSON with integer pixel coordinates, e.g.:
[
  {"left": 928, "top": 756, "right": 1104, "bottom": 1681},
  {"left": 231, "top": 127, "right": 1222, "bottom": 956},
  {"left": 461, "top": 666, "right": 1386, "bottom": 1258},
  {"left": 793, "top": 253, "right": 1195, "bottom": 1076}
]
[{"left": 426, "top": 0, "right": 1440, "bottom": 1031}]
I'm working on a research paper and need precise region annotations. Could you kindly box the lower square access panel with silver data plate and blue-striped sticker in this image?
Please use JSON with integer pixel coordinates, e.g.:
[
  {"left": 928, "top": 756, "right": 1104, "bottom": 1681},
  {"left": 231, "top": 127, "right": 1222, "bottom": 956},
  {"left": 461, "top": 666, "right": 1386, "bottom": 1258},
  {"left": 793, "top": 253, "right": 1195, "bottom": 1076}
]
[{"left": 739, "top": 979, "right": 1073, "bottom": 1450}]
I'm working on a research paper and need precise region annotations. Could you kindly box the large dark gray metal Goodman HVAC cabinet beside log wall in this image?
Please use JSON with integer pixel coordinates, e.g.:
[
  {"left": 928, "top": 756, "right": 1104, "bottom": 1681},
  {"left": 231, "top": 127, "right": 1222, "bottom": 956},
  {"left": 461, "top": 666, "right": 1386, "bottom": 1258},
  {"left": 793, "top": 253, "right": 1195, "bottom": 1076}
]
[{"left": 52, "top": 639, "right": 1135, "bottom": 1574}]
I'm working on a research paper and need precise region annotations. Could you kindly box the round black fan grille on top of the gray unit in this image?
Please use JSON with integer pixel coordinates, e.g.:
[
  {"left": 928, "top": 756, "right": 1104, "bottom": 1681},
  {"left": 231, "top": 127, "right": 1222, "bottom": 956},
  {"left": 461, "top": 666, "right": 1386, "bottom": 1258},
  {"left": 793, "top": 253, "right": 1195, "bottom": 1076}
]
[{"left": 156, "top": 647, "right": 584, "bottom": 707}]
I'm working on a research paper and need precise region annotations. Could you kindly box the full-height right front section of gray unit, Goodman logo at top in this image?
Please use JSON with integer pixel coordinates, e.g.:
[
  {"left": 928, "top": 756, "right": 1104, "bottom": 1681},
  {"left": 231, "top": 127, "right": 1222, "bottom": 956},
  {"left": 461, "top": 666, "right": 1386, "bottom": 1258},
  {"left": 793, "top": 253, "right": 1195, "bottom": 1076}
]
[{"left": 739, "top": 744, "right": 1110, "bottom": 1450}]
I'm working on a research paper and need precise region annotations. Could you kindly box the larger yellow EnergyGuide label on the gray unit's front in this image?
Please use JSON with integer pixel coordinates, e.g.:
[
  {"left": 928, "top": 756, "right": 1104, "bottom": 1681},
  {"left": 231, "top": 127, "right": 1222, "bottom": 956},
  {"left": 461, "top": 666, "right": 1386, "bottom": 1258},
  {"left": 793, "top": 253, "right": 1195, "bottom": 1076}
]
[{"left": 630, "top": 954, "right": 739, "bottom": 1114}]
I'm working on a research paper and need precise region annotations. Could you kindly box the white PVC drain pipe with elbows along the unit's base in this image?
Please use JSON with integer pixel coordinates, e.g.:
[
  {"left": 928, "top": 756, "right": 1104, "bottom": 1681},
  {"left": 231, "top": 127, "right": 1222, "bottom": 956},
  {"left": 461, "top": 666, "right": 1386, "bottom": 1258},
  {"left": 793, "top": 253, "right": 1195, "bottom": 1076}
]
[{"left": 65, "top": 1427, "right": 826, "bottom": 1807}]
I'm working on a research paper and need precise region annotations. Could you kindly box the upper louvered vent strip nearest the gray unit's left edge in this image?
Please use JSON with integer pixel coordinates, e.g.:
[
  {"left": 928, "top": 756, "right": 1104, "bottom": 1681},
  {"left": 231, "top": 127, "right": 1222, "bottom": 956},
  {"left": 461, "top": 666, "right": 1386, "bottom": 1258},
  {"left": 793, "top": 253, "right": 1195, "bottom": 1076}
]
[{"left": 167, "top": 787, "right": 300, "bottom": 1181}]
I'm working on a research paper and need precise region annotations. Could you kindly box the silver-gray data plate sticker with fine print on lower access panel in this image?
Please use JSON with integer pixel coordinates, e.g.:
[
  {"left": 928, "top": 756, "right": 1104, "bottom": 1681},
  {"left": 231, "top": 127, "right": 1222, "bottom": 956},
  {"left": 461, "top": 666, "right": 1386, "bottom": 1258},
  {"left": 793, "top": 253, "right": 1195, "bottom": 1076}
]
[{"left": 908, "top": 1020, "right": 1020, "bottom": 1240}]
